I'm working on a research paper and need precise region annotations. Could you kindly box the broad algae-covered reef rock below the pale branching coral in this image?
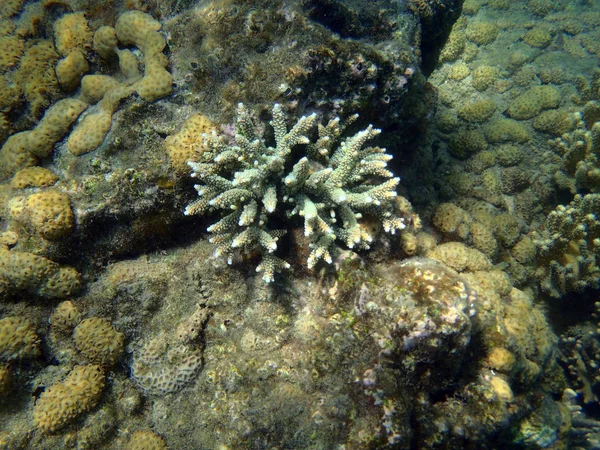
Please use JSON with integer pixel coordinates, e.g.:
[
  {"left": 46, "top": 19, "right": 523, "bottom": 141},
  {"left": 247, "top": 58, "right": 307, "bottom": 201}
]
[{"left": 71, "top": 250, "right": 559, "bottom": 448}]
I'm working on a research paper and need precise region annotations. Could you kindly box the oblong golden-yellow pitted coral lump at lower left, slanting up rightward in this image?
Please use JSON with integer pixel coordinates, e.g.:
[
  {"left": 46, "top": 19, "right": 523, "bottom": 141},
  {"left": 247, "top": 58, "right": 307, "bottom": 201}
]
[{"left": 33, "top": 365, "right": 105, "bottom": 433}]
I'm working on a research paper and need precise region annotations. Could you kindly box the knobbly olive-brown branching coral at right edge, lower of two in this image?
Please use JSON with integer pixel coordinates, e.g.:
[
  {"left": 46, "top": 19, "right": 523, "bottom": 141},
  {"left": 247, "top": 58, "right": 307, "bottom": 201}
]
[{"left": 535, "top": 194, "right": 600, "bottom": 298}]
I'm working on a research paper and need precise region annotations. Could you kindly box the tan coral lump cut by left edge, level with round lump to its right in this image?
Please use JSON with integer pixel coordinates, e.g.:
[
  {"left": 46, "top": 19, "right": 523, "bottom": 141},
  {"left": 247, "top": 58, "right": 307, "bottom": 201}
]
[{"left": 0, "top": 317, "right": 40, "bottom": 361}]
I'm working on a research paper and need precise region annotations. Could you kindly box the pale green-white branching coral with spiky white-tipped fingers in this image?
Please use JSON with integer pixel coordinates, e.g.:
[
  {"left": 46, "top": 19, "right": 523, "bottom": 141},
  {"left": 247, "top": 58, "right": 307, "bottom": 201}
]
[{"left": 185, "top": 104, "right": 405, "bottom": 282}]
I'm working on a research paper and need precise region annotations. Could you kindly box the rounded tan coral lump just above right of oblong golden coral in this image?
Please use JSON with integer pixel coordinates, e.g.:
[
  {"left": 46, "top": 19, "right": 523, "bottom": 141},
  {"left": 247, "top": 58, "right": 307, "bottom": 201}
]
[{"left": 73, "top": 317, "right": 125, "bottom": 366}]
